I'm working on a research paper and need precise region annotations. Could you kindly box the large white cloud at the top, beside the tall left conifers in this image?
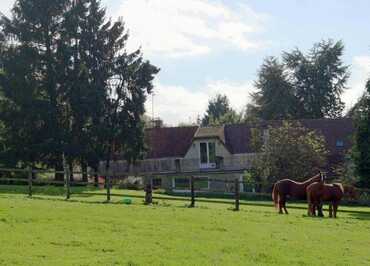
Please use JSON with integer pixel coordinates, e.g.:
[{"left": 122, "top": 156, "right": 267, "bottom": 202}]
[{"left": 116, "top": 0, "right": 266, "bottom": 57}]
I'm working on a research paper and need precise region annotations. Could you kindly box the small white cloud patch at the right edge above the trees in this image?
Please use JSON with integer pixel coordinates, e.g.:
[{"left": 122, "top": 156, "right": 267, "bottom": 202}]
[{"left": 342, "top": 56, "right": 370, "bottom": 110}]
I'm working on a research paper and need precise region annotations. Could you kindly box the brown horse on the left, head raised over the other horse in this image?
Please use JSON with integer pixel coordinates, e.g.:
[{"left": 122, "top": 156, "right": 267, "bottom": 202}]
[{"left": 272, "top": 172, "right": 323, "bottom": 214}]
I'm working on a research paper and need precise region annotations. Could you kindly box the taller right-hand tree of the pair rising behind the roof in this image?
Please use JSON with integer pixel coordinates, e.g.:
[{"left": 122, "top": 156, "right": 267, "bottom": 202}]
[{"left": 283, "top": 40, "right": 349, "bottom": 118}]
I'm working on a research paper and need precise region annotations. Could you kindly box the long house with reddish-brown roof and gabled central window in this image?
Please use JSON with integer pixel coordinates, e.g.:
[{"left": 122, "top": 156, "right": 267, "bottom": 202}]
[{"left": 104, "top": 118, "right": 354, "bottom": 192}]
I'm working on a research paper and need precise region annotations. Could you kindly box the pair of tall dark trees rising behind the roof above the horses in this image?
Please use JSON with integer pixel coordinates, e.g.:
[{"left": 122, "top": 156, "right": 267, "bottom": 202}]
[{"left": 252, "top": 40, "right": 349, "bottom": 119}]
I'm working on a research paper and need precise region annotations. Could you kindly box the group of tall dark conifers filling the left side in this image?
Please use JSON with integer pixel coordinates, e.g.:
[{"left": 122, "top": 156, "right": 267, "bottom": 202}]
[{"left": 0, "top": 0, "right": 159, "bottom": 178}]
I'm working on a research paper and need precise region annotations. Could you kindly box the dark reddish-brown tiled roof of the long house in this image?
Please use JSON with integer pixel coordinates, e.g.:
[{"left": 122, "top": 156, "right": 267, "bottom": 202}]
[{"left": 146, "top": 118, "right": 354, "bottom": 159}]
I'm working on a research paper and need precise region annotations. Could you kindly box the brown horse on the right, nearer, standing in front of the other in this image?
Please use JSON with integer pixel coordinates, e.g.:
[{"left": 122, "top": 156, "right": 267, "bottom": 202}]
[{"left": 306, "top": 182, "right": 345, "bottom": 218}]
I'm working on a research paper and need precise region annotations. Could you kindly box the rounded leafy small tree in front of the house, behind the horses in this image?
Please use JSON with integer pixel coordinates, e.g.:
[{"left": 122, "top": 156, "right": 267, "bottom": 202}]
[{"left": 253, "top": 121, "right": 328, "bottom": 184}]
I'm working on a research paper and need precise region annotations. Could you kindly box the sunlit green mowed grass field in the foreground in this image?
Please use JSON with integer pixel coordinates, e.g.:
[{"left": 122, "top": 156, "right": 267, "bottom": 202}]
[{"left": 0, "top": 187, "right": 370, "bottom": 266}]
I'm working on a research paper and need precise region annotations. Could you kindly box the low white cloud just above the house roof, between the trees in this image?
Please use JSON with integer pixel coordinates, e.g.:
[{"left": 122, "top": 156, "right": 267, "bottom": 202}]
[{"left": 146, "top": 80, "right": 253, "bottom": 126}]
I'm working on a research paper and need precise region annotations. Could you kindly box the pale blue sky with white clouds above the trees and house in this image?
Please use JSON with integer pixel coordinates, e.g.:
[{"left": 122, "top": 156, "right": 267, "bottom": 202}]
[{"left": 0, "top": 0, "right": 370, "bottom": 126}]
